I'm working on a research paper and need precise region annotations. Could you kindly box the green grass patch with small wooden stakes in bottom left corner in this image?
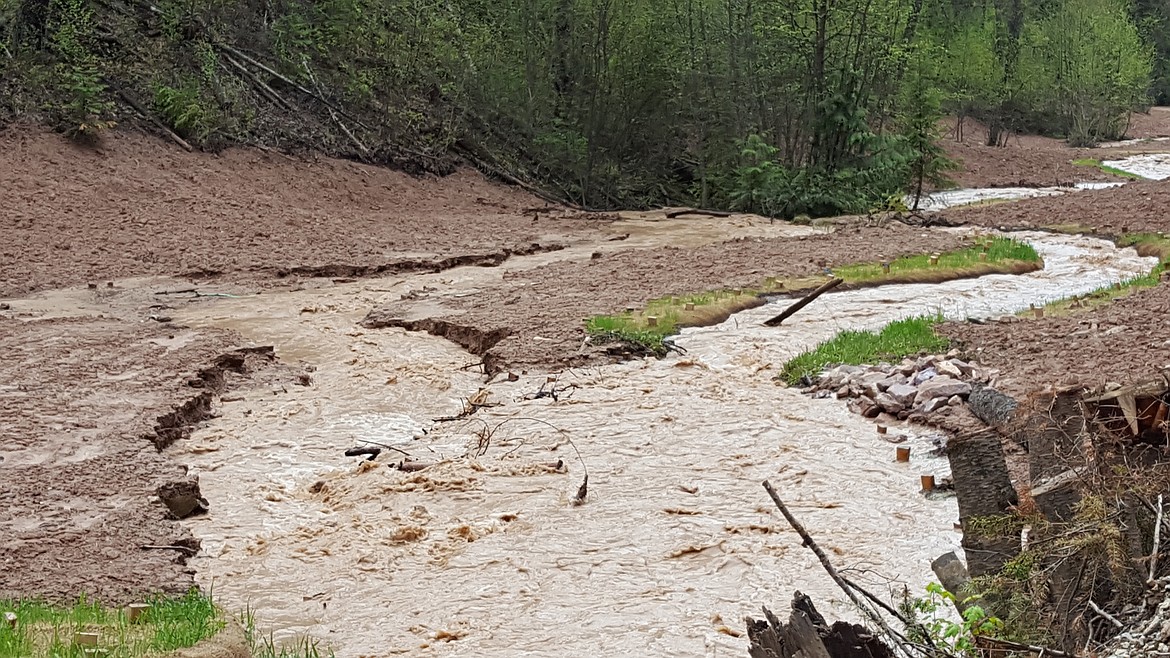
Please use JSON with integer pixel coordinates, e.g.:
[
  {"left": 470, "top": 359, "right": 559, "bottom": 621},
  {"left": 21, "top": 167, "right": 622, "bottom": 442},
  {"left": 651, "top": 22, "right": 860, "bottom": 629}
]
[{"left": 0, "top": 589, "right": 226, "bottom": 658}]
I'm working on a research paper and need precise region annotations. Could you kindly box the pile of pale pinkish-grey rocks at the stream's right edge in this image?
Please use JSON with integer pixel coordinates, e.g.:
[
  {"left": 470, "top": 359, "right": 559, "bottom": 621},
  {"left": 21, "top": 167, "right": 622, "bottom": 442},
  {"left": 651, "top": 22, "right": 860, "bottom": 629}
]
[{"left": 805, "top": 351, "right": 995, "bottom": 420}]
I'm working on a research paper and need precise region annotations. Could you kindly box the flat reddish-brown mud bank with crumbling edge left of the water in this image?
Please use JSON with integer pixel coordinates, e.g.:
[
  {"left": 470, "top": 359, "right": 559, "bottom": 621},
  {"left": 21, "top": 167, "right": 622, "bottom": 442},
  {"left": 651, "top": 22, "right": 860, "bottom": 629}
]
[{"left": 0, "top": 299, "right": 281, "bottom": 604}]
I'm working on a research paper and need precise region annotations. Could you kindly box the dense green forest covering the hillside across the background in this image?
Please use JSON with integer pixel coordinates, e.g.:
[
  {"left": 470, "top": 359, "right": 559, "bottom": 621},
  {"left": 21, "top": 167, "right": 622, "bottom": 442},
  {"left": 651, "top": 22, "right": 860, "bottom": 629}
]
[{"left": 0, "top": 0, "right": 1155, "bottom": 219}]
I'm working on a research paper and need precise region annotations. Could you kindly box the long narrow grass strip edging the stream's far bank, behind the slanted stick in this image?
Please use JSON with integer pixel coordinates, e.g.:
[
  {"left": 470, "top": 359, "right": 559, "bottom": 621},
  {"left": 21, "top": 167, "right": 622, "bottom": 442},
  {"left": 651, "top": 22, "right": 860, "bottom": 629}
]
[{"left": 585, "top": 237, "right": 1042, "bottom": 356}]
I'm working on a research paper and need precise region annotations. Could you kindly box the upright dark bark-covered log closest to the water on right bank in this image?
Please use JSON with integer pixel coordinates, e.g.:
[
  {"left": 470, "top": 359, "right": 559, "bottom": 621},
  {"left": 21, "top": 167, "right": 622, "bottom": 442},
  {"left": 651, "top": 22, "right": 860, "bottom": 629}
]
[{"left": 947, "top": 430, "right": 1020, "bottom": 577}]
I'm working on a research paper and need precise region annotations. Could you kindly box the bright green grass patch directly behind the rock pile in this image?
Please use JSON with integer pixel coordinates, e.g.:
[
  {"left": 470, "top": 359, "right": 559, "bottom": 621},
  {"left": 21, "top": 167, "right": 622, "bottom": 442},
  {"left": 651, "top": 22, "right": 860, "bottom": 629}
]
[{"left": 779, "top": 314, "right": 950, "bottom": 384}]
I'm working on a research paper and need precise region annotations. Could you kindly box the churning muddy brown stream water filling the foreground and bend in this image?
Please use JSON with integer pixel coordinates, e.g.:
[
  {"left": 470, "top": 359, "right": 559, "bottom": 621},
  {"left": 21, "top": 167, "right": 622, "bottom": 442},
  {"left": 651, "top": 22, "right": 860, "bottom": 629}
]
[{"left": 172, "top": 223, "right": 1152, "bottom": 657}]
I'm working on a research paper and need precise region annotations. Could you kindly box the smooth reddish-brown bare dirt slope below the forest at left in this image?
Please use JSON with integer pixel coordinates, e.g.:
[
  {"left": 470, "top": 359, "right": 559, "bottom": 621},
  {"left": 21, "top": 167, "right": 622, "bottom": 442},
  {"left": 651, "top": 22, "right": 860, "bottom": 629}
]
[{"left": 0, "top": 125, "right": 597, "bottom": 297}]
